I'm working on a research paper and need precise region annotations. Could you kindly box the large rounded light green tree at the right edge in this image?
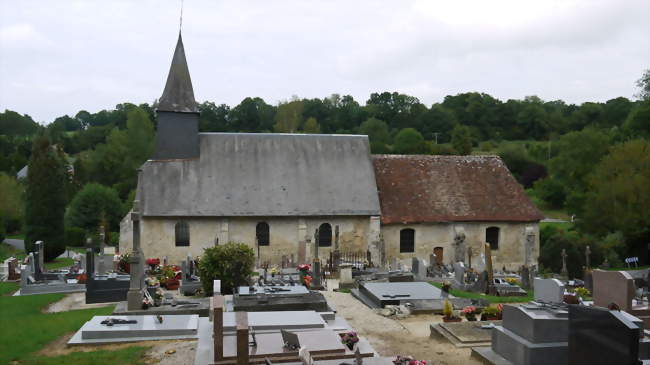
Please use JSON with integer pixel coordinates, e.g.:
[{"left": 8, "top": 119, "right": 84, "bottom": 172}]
[{"left": 579, "top": 139, "right": 650, "bottom": 256}]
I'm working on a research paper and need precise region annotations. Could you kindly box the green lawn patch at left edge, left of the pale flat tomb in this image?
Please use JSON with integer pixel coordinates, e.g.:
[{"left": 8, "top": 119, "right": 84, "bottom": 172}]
[{"left": 0, "top": 286, "right": 114, "bottom": 364}]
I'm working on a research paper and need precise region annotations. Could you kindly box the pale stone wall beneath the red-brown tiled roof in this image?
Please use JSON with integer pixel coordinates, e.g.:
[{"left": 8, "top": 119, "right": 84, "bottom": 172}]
[{"left": 381, "top": 222, "right": 539, "bottom": 270}]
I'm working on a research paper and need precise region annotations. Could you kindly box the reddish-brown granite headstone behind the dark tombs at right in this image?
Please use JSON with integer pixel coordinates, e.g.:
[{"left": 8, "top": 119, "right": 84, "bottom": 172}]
[{"left": 592, "top": 270, "right": 635, "bottom": 312}]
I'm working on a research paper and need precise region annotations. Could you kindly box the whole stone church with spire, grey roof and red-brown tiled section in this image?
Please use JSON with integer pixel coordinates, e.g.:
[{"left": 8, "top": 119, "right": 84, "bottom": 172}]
[{"left": 120, "top": 34, "right": 542, "bottom": 269}]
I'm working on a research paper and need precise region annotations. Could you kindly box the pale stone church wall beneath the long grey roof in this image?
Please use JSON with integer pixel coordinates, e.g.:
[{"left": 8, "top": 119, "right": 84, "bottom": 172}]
[{"left": 120, "top": 216, "right": 371, "bottom": 265}]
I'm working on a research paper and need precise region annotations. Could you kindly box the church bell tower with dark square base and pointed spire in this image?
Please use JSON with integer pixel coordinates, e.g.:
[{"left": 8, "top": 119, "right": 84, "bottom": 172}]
[{"left": 152, "top": 32, "right": 200, "bottom": 160}]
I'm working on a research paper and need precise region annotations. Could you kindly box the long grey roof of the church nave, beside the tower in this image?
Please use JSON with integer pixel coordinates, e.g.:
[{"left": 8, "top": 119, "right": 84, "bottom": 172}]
[{"left": 140, "top": 133, "right": 380, "bottom": 216}]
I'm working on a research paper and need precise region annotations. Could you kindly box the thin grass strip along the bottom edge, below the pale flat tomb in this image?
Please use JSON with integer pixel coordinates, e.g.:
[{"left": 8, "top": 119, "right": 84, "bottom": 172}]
[{"left": 21, "top": 346, "right": 149, "bottom": 365}]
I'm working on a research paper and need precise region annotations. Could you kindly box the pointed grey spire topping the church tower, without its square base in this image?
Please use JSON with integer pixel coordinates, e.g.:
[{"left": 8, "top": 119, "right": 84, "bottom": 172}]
[{"left": 158, "top": 32, "right": 199, "bottom": 113}]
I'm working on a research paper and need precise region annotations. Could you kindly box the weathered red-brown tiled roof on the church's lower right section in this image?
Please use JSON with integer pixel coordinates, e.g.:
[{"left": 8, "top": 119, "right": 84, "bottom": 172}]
[{"left": 373, "top": 155, "right": 543, "bottom": 224}]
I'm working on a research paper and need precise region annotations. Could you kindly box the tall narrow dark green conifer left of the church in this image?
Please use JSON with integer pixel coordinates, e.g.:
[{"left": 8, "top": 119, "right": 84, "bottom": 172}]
[{"left": 25, "top": 137, "right": 68, "bottom": 261}]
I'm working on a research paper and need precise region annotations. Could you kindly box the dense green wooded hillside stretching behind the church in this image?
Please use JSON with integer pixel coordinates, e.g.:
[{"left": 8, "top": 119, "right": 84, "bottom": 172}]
[{"left": 0, "top": 70, "right": 650, "bottom": 270}]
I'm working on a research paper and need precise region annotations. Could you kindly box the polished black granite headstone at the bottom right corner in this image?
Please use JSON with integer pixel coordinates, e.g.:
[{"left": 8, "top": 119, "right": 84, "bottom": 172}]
[{"left": 569, "top": 305, "right": 641, "bottom": 365}]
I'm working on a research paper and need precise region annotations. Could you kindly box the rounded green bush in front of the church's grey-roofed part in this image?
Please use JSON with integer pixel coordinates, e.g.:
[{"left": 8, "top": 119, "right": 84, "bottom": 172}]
[{"left": 199, "top": 242, "right": 255, "bottom": 296}]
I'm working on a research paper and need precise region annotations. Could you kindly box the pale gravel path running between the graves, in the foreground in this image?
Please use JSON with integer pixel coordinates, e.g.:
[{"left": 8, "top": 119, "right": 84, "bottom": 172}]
[{"left": 323, "top": 292, "right": 481, "bottom": 365}]
